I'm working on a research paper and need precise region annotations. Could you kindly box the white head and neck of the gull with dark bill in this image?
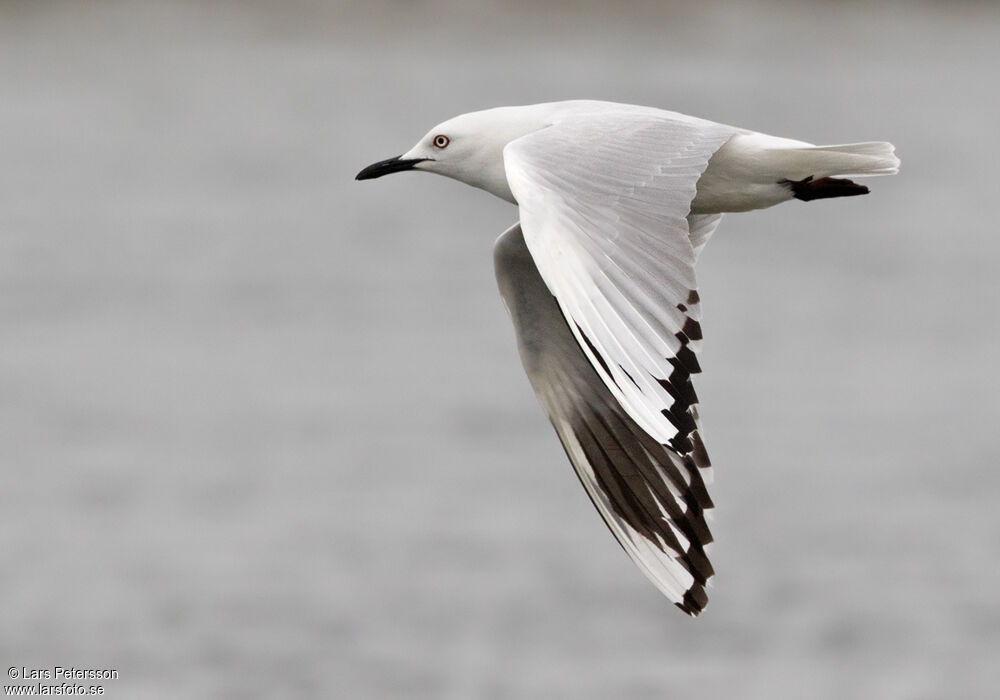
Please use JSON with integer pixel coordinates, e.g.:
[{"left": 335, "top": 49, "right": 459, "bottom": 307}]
[{"left": 355, "top": 105, "right": 551, "bottom": 202}]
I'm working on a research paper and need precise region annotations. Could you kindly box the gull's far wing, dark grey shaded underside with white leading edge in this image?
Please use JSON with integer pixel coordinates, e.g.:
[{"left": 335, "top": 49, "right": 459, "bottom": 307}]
[{"left": 494, "top": 224, "right": 713, "bottom": 615}]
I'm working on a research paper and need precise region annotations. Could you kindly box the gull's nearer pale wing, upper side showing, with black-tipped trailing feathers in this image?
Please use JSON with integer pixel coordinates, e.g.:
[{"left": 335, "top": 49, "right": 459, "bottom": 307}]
[{"left": 504, "top": 110, "right": 736, "bottom": 453}]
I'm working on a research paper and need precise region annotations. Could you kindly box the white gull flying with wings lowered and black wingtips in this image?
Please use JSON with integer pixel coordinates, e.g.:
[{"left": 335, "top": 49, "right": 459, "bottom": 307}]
[{"left": 356, "top": 100, "right": 899, "bottom": 616}]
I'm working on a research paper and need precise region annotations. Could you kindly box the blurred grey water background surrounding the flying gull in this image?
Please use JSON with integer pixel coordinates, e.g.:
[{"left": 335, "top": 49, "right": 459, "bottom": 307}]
[{"left": 0, "top": 0, "right": 1000, "bottom": 700}]
